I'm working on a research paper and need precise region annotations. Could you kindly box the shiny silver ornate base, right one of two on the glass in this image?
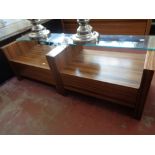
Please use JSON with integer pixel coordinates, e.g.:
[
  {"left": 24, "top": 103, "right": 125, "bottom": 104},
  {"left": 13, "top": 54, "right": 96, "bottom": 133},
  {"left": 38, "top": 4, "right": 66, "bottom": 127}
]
[{"left": 72, "top": 19, "right": 99, "bottom": 44}]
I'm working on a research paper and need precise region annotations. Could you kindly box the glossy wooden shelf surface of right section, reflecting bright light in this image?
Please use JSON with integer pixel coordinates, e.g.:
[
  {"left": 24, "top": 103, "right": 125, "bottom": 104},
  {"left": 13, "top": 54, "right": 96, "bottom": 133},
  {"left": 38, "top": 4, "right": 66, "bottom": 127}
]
[{"left": 62, "top": 47, "right": 145, "bottom": 88}]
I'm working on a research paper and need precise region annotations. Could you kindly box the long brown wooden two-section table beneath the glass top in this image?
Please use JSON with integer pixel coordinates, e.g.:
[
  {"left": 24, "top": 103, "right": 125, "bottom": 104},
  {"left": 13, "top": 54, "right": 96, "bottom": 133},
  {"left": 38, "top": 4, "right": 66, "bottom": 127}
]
[{"left": 3, "top": 41, "right": 155, "bottom": 119}]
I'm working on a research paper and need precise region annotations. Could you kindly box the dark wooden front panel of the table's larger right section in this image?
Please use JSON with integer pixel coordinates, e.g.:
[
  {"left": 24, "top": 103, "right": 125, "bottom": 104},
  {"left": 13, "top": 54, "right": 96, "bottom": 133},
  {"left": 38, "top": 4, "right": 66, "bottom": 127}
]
[{"left": 62, "top": 74, "right": 138, "bottom": 107}]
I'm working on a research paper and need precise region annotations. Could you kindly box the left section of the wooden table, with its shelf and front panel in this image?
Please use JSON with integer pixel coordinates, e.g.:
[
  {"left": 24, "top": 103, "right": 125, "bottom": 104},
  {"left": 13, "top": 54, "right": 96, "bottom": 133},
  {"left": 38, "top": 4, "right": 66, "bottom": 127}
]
[{"left": 3, "top": 41, "right": 55, "bottom": 84}]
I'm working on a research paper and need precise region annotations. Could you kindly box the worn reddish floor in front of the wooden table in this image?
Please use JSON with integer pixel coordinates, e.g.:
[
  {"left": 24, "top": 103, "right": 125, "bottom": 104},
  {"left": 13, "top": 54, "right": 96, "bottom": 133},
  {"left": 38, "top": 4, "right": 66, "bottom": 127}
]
[{"left": 0, "top": 76, "right": 155, "bottom": 134}]
